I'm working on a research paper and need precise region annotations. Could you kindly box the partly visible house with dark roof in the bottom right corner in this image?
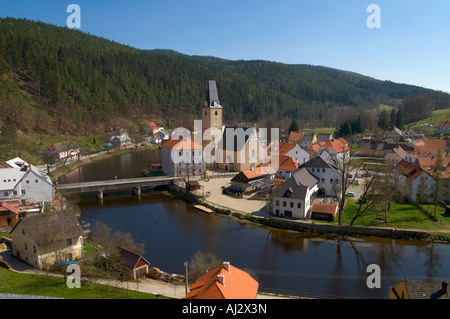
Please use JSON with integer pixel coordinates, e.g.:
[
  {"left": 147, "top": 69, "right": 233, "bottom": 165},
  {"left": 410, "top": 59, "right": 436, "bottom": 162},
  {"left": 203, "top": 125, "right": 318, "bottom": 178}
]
[{"left": 389, "top": 279, "right": 450, "bottom": 299}]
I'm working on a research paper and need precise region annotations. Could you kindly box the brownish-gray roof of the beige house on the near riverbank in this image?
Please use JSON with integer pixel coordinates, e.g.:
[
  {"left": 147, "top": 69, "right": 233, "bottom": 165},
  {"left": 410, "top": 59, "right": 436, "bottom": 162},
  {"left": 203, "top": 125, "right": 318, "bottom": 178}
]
[{"left": 11, "top": 209, "right": 83, "bottom": 246}]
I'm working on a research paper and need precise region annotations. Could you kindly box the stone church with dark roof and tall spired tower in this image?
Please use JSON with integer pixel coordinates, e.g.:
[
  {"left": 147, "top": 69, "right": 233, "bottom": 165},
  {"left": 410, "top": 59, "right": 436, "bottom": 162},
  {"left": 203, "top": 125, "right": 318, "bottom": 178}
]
[{"left": 202, "top": 80, "right": 268, "bottom": 172}]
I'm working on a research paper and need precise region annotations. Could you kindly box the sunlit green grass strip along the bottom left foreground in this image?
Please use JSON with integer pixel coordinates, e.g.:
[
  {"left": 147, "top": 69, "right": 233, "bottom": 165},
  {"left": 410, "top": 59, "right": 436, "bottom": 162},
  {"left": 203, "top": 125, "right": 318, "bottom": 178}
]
[{"left": 0, "top": 267, "right": 167, "bottom": 299}]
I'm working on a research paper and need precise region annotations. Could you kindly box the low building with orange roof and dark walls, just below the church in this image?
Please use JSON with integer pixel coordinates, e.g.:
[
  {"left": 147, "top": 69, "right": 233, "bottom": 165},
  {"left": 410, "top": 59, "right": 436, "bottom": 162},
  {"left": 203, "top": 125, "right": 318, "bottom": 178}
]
[{"left": 230, "top": 166, "right": 275, "bottom": 193}]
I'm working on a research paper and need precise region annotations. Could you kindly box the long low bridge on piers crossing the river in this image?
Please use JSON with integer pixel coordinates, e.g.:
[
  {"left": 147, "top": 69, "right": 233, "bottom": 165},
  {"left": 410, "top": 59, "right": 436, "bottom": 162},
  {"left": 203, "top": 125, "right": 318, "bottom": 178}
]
[{"left": 56, "top": 176, "right": 184, "bottom": 199}]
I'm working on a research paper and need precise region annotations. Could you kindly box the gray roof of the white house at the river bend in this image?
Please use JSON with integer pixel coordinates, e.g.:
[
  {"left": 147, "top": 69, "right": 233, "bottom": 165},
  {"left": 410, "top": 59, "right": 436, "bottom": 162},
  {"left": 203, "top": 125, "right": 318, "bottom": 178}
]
[{"left": 273, "top": 168, "right": 319, "bottom": 199}]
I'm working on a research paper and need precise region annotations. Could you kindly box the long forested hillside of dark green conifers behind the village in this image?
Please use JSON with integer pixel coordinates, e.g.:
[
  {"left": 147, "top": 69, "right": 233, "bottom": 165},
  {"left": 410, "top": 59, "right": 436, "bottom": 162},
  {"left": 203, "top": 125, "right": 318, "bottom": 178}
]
[{"left": 0, "top": 18, "right": 442, "bottom": 135}]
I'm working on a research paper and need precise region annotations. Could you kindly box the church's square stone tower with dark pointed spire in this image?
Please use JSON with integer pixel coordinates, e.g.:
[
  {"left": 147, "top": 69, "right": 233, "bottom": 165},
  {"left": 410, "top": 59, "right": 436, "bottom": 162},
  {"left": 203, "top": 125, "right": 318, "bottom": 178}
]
[{"left": 202, "top": 80, "right": 222, "bottom": 146}]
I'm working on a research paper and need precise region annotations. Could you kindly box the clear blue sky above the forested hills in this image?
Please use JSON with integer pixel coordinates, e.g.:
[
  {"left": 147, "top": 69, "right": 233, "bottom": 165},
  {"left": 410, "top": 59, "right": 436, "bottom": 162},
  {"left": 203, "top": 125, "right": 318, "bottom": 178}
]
[{"left": 0, "top": 0, "right": 450, "bottom": 93}]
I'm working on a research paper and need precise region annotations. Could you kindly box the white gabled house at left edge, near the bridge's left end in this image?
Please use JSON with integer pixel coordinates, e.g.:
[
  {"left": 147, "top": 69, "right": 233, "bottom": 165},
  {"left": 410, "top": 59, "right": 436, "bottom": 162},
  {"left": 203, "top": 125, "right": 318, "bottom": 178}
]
[{"left": 0, "top": 157, "right": 53, "bottom": 204}]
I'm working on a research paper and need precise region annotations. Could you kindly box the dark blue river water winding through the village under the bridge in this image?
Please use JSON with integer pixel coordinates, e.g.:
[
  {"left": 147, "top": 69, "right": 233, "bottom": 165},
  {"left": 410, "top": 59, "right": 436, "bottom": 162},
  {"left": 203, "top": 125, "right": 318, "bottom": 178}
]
[{"left": 59, "top": 150, "right": 450, "bottom": 299}]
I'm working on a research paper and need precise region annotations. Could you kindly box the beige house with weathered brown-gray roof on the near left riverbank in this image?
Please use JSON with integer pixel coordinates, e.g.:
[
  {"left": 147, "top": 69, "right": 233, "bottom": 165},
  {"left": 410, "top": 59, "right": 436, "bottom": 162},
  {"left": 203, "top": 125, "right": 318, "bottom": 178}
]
[{"left": 11, "top": 209, "right": 83, "bottom": 269}]
